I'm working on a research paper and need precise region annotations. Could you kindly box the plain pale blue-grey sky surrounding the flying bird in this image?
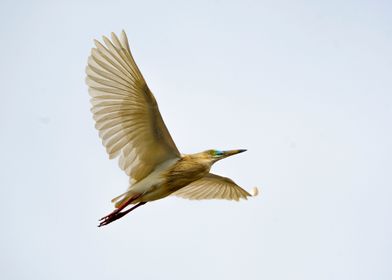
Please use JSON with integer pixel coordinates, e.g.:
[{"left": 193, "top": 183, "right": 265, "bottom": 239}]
[{"left": 0, "top": 0, "right": 392, "bottom": 280}]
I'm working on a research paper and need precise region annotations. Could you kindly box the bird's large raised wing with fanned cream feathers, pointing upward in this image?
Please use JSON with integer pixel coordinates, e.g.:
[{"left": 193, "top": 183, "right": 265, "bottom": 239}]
[{"left": 86, "top": 31, "right": 180, "bottom": 181}]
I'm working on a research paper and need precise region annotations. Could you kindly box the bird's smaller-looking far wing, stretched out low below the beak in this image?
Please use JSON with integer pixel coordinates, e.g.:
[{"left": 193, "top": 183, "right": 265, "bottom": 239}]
[{"left": 172, "top": 173, "right": 252, "bottom": 201}]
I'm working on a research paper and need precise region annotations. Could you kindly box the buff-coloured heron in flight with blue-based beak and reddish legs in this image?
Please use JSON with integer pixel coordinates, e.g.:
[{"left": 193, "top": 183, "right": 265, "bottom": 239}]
[{"left": 86, "top": 30, "right": 258, "bottom": 227}]
